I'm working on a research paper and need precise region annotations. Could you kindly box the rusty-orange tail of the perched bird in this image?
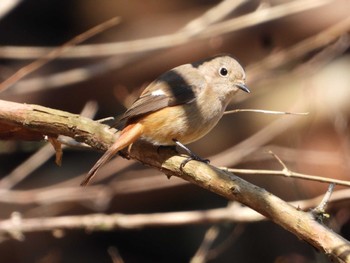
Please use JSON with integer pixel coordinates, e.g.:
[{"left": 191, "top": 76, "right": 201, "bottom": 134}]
[{"left": 80, "top": 123, "right": 143, "bottom": 186}]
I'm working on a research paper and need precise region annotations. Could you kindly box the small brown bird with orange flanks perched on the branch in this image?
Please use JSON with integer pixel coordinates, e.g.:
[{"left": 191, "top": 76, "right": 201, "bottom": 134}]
[{"left": 81, "top": 55, "right": 250, "bottom": 186}]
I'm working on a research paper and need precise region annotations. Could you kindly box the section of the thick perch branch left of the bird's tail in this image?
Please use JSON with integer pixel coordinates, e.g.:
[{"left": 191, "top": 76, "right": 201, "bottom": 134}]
[{"left": 0, "top": 100, "right": 116, "bottom": 150}]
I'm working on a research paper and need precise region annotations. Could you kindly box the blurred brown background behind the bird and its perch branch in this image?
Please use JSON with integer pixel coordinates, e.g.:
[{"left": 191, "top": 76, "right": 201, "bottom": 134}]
[{"left": 0, "top": 0, "right": 350, "bottom": 263}]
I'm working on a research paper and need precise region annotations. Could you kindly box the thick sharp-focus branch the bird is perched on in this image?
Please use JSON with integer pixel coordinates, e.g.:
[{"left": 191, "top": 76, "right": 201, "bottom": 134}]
[{"left": 0, "top": 101, "right": 350, "bottom": 262}]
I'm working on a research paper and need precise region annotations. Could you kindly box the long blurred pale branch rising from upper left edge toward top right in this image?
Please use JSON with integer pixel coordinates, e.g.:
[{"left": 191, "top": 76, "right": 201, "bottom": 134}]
[{"left": 0, "top": 0, "right": 331, "bottom": 59}]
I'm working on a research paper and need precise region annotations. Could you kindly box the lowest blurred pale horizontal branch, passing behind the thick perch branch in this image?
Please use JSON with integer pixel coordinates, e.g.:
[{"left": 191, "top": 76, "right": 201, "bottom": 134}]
[{"left": 0, "top": 190, "right": 350, "bottom": 237}]
